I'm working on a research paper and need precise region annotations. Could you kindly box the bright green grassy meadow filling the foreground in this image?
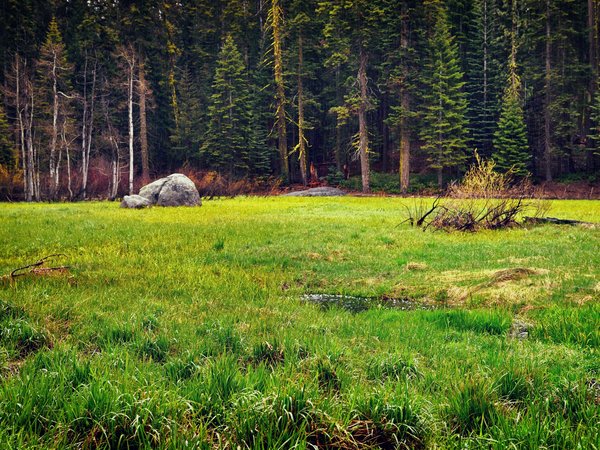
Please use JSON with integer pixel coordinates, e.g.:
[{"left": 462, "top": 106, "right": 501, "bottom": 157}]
[{"left": 0, "top": 197, "right": 600, "bottom": 449}]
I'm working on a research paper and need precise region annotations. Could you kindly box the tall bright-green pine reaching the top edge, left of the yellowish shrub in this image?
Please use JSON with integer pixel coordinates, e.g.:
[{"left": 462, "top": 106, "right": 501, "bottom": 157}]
[{"left": 421, "top": 0, "right": 467, "bottom": 188}]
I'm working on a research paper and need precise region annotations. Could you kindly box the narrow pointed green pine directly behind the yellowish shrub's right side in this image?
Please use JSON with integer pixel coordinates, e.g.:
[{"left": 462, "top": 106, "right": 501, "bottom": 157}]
[{"left": 494, "top": 46, "right": 530, "bottom": 176}]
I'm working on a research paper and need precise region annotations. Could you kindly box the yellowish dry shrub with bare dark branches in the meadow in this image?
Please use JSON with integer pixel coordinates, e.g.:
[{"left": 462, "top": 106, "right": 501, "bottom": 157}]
[{"left": 408, "top": 153, "right": 550, "bottom": 231}]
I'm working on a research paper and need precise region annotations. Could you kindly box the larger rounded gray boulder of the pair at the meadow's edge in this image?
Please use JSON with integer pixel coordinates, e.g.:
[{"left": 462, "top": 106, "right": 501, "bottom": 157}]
[{"left": 140, "top": 173, "right": 202, "bottom": 206}]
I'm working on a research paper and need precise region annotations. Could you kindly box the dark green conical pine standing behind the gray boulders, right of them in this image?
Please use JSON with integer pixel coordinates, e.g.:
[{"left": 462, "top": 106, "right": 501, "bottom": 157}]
[{"left": 200, "top": 34, "right": 253, "bottom": 176}]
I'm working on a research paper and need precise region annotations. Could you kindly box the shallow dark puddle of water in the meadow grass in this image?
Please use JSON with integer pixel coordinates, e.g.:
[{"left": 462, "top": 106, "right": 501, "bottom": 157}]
[{"left": 301, "top": 294, "right": 436, "bottom": 313}]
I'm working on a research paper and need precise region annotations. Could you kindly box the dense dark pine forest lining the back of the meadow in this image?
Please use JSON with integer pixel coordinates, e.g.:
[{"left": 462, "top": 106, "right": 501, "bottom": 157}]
[{"left": 0, "top": 0, "right": 600, "bottom": 201}]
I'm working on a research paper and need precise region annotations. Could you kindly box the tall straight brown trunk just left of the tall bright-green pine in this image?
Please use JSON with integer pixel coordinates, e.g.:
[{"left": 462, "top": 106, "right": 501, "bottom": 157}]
[{"left": 399, "top": 13, "right": 410, "bottom": 194}]
